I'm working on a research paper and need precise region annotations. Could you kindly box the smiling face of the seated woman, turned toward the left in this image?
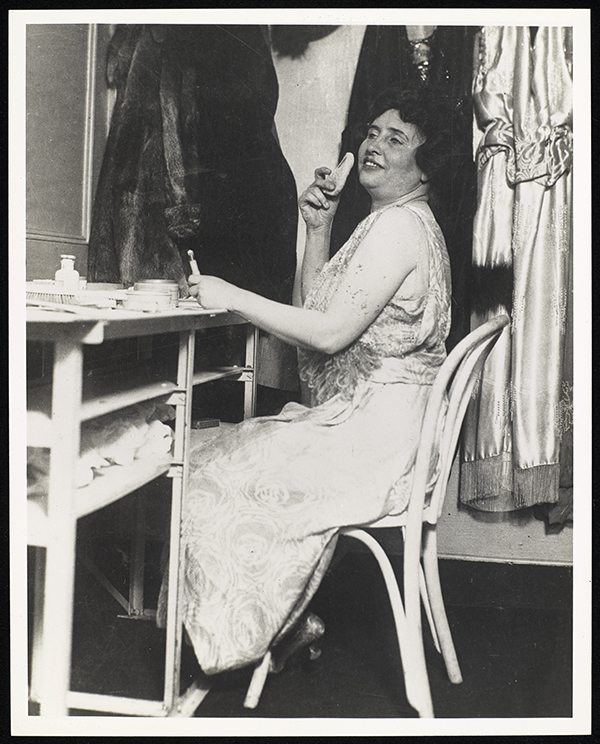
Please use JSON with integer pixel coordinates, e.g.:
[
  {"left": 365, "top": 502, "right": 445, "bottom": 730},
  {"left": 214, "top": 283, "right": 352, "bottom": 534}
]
[{"left": 358, "top": 109, "right": 425, "bottom": 209}]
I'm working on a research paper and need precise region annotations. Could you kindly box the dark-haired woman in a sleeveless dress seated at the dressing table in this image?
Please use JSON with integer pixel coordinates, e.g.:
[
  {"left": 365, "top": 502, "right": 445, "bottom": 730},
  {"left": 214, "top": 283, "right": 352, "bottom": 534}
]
[{"left": 168, "top": 85, "right": 450, "bottom": 674}]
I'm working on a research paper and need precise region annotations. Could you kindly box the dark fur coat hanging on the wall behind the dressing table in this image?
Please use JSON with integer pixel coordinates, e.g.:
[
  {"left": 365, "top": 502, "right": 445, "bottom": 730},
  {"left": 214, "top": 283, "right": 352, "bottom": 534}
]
[{"left": 88, "top": 25, "right": 297, "bottom": 302}]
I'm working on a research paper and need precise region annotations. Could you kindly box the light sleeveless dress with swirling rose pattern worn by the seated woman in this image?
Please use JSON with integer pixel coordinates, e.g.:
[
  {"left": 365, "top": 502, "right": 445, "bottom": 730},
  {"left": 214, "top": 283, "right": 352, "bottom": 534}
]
[{"left": 173, "top": 190, "right": 450, "bottom": 674}]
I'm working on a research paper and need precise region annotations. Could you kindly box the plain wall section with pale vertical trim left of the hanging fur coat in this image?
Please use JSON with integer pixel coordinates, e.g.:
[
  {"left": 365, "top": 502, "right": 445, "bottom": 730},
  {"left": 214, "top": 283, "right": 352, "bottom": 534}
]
[{"left": 26, "top": 24, "right": 111, "bottom": 280}]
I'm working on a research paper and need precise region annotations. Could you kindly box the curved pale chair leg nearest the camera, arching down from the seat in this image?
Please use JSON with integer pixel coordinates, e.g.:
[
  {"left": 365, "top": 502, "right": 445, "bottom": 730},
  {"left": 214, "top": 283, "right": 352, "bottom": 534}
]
[{"left": 343, "top": 528, "right": 433, "bottom": 718}]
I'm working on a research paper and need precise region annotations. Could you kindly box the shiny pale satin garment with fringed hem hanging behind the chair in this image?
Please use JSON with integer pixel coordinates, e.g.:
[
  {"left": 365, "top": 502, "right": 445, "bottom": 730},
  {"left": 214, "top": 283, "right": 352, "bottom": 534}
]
[{"left": 460, "top": 27, "right": 572, "bottom": 511}]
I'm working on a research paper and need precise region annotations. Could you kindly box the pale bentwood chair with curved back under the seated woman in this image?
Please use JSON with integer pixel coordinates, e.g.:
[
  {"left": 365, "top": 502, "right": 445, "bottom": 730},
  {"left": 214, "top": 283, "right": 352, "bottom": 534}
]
[{"left": 244, "top": 315, "right": 510, "bottom": 718}]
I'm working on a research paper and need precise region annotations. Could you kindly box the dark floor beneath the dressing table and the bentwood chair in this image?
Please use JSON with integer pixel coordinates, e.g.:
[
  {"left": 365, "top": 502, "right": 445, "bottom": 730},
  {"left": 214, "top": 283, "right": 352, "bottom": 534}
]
[{"left": 31, "top": 502, "right": 572, "bottom": 718}]
